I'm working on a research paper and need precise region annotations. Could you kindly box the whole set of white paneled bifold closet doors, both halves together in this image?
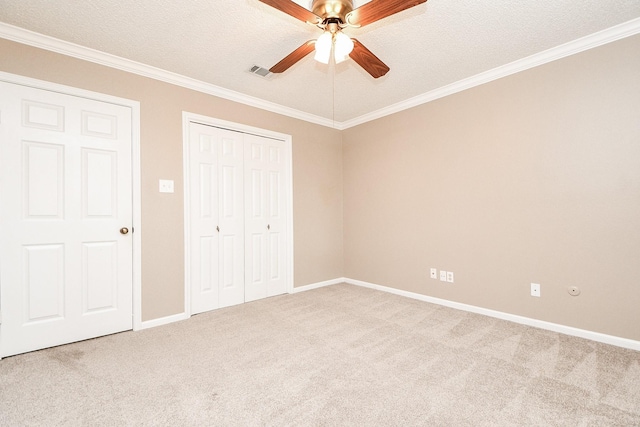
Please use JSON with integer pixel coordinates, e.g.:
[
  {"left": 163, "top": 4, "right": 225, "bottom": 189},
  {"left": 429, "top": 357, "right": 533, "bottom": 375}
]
[{"left": 188, "top": 122, "right": 286, "bottom": 314}]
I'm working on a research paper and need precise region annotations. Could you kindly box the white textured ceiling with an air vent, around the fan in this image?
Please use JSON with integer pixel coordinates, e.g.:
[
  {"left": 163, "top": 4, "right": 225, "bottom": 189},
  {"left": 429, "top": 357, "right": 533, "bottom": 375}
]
[{"left": 0, "top": 0, "right": 640, "bottom": 122}]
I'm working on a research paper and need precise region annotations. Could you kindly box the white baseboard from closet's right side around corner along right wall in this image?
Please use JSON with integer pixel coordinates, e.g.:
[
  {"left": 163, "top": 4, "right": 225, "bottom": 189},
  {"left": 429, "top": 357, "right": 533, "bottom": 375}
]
[{"left": 294, "top": 277, "right": 640, "bottom": 351}]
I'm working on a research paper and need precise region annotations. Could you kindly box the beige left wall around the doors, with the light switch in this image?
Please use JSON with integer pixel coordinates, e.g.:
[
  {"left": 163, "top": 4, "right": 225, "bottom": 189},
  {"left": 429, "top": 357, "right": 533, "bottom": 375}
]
[{"left": 0, "top": 39, "right": 344, "bottom": 320}]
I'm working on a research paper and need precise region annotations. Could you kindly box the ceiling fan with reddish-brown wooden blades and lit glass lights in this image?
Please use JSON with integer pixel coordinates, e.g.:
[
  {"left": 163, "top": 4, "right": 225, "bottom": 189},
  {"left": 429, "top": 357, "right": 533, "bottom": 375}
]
[{"left": 260, "top": 0, "right": 427, "bottom": 79}]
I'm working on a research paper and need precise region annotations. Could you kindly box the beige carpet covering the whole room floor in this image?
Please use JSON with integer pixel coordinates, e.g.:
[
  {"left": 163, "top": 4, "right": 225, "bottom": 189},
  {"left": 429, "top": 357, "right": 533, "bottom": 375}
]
[{"left": 0, "top": 285, "right": 640, "bottom": 426}]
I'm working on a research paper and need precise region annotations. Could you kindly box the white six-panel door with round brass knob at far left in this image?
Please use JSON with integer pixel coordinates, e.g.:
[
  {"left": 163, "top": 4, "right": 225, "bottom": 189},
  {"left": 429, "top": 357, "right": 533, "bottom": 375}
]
[{"left": 0, "top": 82, "right": 132, "bottom": 356}]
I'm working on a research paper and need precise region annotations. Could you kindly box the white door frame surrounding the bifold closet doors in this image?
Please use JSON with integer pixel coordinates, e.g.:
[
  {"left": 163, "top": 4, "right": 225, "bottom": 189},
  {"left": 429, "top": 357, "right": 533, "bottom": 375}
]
[{"left": 182, "top": 111, "right": 293, "bottom": 317}]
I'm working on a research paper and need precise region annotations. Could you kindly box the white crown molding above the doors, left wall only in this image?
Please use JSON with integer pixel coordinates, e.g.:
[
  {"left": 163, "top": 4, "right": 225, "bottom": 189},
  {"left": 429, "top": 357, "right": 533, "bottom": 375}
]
[{"left": 0, "top": 22, "right": 335, "bottom": 127}]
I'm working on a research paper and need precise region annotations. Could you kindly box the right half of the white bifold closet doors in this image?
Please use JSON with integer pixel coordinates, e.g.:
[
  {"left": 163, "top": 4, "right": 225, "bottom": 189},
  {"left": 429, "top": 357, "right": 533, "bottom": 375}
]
[{"left": 244, "top": 135, "right": 286, "bottom": 301}]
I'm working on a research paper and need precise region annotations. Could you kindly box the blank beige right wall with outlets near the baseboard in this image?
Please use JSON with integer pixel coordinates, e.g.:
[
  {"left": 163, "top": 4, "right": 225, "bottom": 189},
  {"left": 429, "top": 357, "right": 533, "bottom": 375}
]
[{"left": 343, "top": 32, "right": 640, "bottom": 340}]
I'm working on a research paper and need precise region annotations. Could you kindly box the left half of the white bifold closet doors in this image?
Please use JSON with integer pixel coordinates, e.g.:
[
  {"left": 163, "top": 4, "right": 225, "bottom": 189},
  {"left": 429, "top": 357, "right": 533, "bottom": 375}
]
[{"left": 189, "top": 123, "right": 244, "bottom": 314}]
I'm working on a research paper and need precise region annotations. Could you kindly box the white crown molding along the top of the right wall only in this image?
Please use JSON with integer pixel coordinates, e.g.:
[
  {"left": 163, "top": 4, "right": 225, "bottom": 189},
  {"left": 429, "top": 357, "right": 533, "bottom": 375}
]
[{"left": 336, "top": 18, "right": 640, "bottom": 130}]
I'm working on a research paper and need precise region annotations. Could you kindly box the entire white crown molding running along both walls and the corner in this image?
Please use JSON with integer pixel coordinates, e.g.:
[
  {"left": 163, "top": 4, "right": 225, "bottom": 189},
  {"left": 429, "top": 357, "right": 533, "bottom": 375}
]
[{"left": 0, "top": 18, "right": 640, "bottom": 130}]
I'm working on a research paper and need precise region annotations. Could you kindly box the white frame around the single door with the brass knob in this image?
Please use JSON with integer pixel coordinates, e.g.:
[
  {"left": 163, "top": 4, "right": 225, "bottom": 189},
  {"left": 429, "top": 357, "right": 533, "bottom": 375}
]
[{"left": 0, "top": 71, "right": 142, "bottom": 331}]
